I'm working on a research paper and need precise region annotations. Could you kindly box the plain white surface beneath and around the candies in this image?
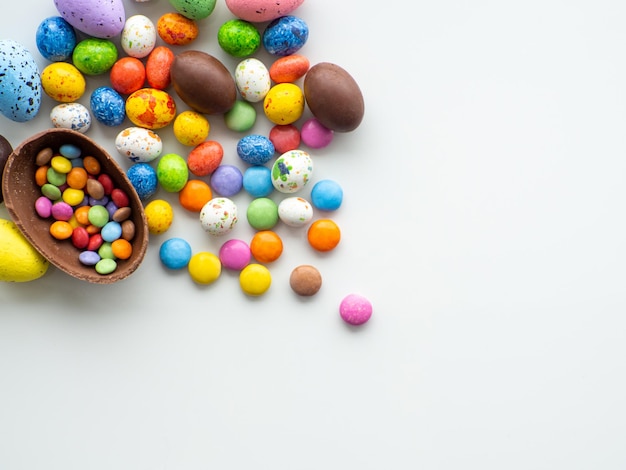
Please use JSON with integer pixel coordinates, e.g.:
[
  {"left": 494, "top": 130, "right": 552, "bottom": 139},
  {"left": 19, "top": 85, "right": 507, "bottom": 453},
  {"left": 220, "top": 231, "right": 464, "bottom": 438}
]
[{"left": 0, "top": 0, "right": 626, "bottom": 470}]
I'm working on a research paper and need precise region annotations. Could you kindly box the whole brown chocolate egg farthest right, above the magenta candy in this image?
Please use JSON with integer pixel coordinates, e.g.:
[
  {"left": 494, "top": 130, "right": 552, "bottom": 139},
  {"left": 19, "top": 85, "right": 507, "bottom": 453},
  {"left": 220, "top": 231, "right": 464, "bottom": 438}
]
[{"left": 303, "top": 62, "right": 365, "bottom": 132}]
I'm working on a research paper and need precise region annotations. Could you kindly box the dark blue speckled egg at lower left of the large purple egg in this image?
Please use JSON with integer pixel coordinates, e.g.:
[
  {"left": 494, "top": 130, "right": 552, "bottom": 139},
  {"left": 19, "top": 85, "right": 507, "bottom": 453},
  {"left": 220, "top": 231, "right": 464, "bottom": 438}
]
[{"left": 35, "top": 16, "right": 76, "bottom": 62}]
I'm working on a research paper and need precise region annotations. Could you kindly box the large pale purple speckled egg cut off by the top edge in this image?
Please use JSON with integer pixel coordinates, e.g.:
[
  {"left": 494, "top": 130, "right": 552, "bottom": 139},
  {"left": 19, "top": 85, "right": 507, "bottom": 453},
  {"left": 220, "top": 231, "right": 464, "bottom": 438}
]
[{"left": 54, "top": 0, "right": 126, "bottom": 38}]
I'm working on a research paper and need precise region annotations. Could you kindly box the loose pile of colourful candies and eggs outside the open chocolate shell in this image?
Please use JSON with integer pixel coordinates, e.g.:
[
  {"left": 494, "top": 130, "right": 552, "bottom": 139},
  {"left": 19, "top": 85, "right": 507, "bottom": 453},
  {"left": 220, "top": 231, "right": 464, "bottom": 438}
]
[{"left": 0, "top": 0, "right": 372, "bottom": 325}]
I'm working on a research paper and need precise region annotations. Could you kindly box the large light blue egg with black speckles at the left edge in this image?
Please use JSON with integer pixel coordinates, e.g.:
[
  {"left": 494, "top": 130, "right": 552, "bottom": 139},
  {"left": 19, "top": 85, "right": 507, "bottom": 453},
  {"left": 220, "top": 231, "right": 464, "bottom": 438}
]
[{"left": 0, "top": 39, "right": 42, "bottom": 122}]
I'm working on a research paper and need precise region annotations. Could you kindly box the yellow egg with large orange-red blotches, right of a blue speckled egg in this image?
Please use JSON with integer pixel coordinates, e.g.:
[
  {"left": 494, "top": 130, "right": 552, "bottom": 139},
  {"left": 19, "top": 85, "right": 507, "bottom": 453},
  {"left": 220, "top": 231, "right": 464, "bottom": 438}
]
[{"left": 126, "top": 88, "right": 176, "bottom": 129}]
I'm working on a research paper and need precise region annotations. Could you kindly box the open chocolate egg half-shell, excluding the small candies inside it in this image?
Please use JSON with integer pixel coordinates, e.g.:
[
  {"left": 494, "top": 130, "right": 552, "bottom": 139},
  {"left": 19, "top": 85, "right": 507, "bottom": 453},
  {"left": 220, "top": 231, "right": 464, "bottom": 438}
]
[{"left": 2, "top": 129, "right": 148, "bottom": 284}]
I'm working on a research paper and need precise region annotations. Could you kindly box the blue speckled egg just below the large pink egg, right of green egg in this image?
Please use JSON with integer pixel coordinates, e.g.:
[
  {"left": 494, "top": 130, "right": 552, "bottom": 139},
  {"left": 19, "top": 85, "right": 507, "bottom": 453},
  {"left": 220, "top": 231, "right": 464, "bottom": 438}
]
[{"left": 262, "top": 15, "right": 309, "bottom": 56}]
